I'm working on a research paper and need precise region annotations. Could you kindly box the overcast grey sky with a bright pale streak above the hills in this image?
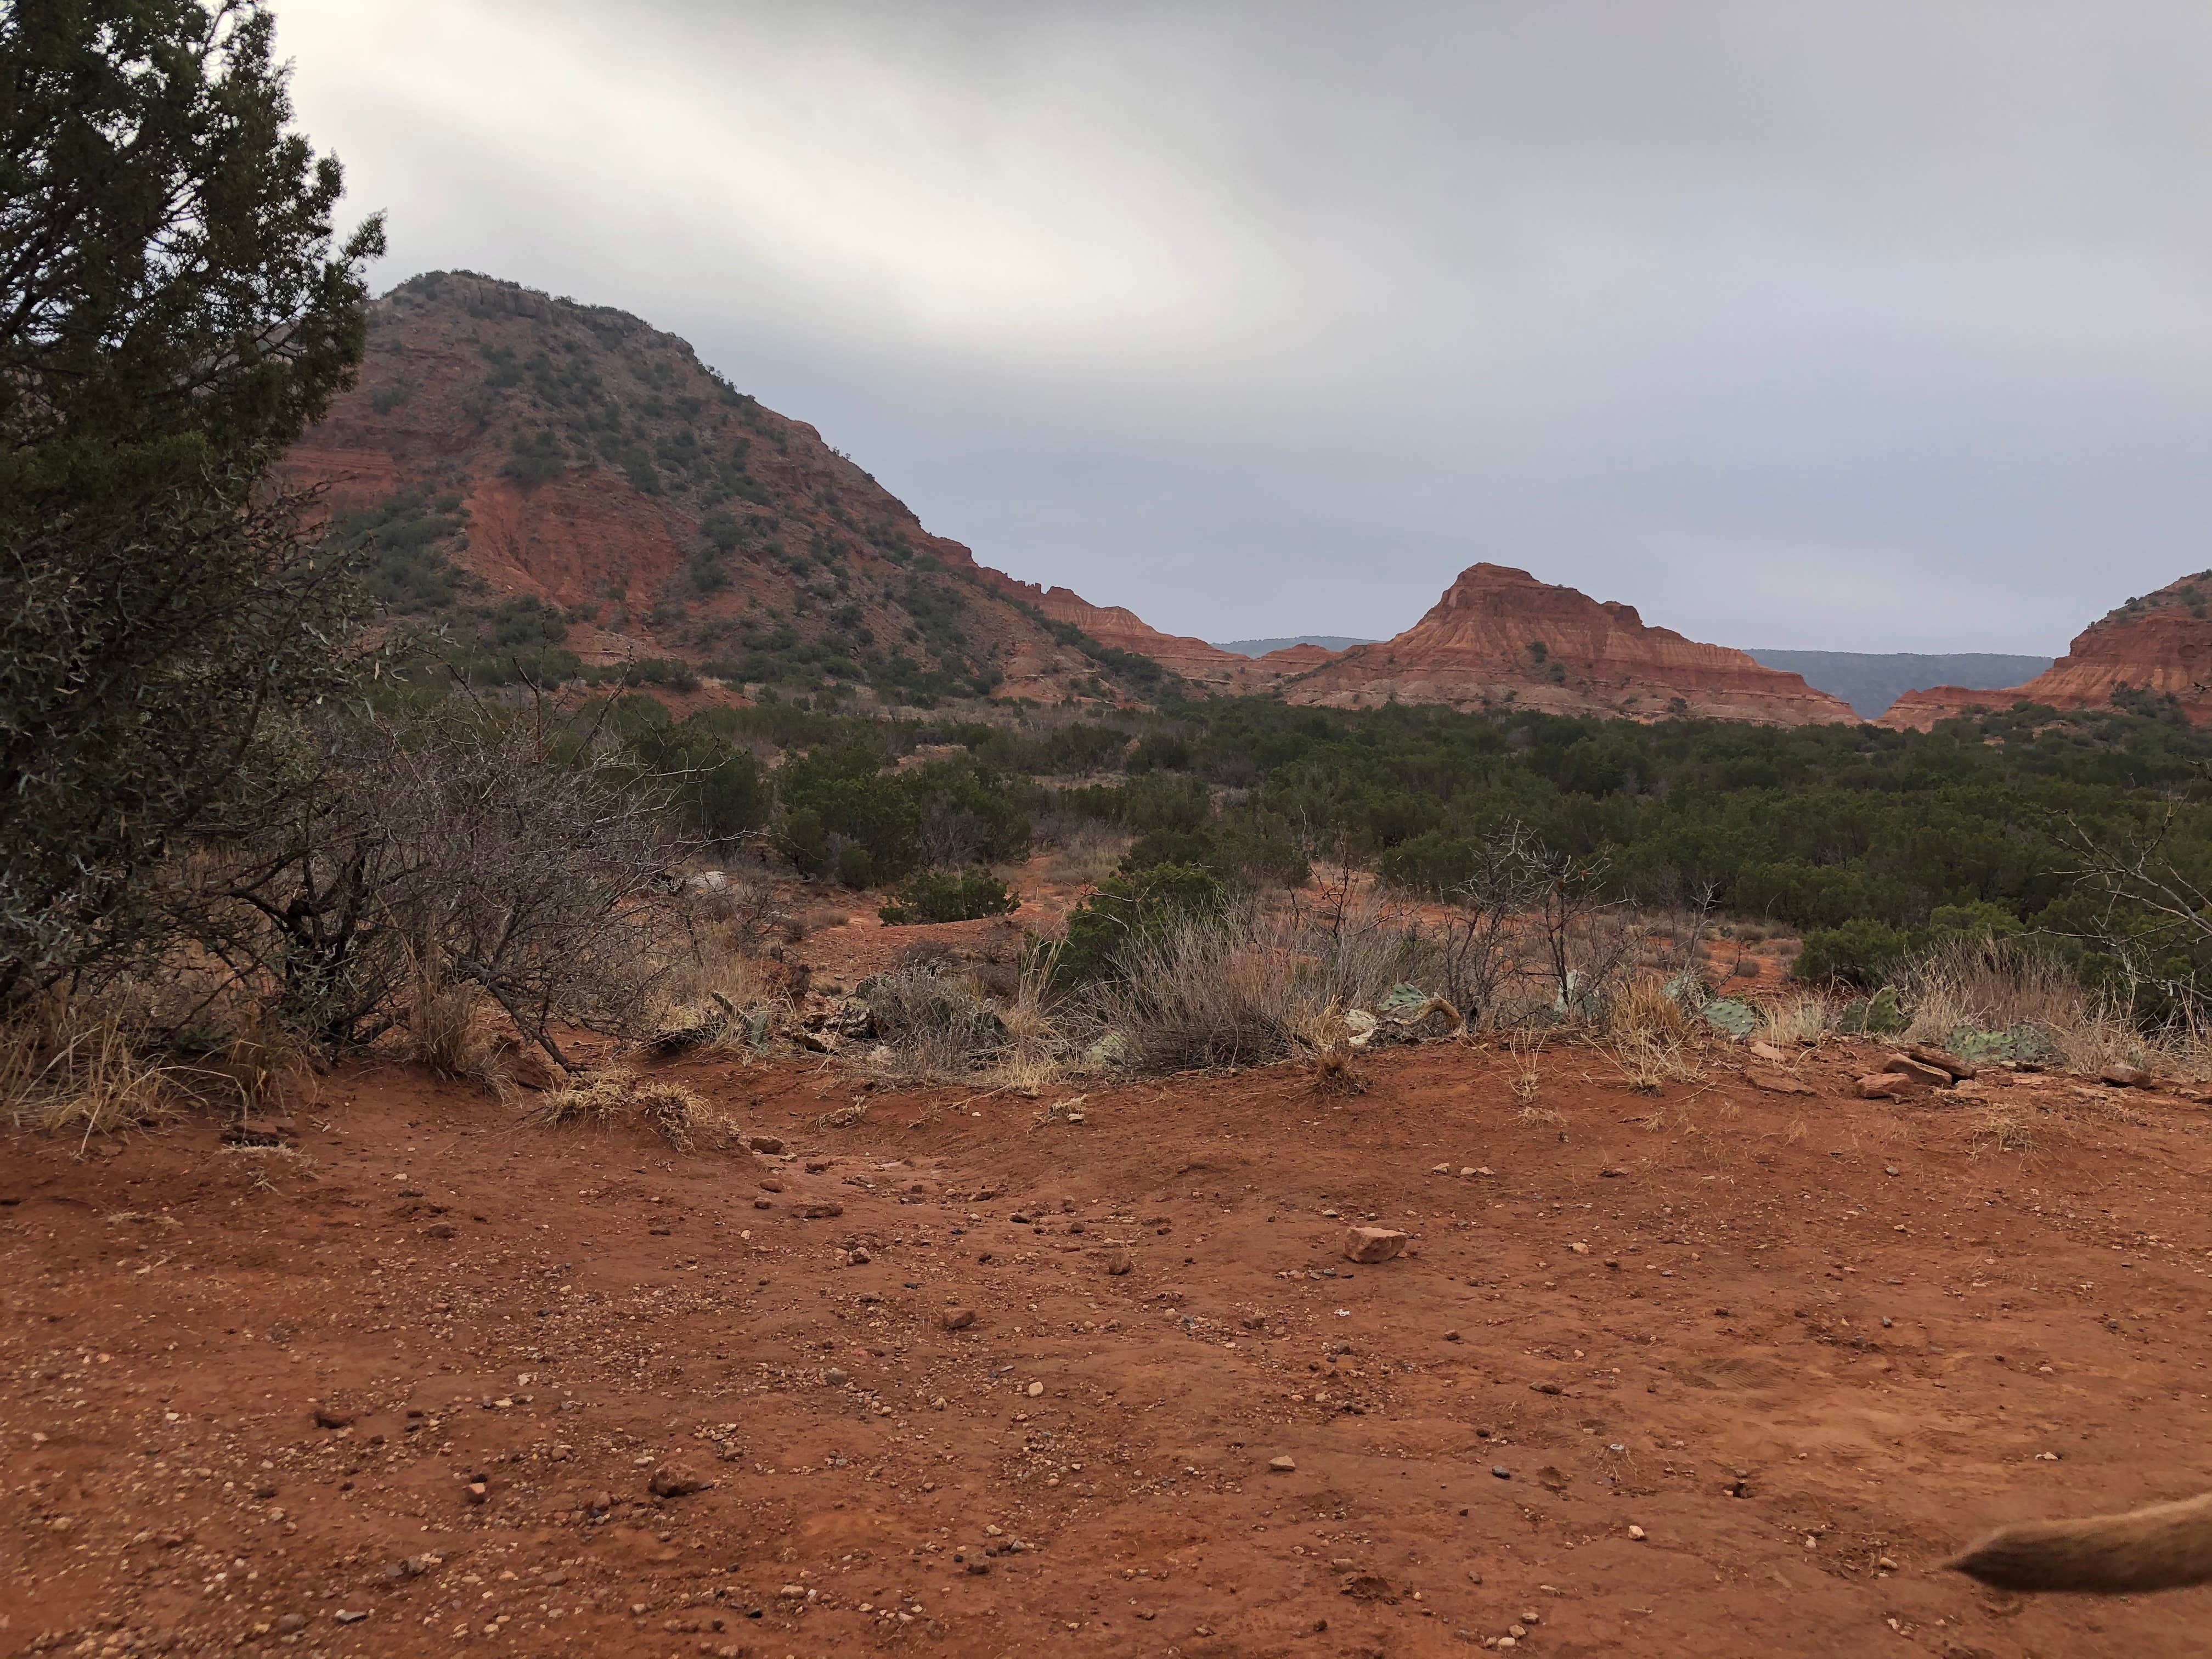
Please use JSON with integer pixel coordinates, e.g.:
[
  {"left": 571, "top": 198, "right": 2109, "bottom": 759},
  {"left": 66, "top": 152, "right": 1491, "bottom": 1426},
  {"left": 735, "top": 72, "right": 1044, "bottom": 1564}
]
[{"left": 276, "top": 0, "right": 2212, "bottom": 652}]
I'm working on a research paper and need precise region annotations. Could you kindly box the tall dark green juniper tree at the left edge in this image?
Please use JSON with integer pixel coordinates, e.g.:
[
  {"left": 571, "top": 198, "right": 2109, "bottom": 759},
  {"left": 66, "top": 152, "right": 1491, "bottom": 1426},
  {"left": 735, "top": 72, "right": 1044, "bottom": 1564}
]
[{"left": 0, "top": 0, "right": 383, "bottom": 1002}]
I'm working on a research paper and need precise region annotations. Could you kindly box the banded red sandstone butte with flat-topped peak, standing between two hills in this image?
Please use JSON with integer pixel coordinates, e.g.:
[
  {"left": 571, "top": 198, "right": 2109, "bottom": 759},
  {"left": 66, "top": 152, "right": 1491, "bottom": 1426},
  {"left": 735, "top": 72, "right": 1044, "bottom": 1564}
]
[{"left": 1274, "top": 564, "right": 1858, "bottom": 725}]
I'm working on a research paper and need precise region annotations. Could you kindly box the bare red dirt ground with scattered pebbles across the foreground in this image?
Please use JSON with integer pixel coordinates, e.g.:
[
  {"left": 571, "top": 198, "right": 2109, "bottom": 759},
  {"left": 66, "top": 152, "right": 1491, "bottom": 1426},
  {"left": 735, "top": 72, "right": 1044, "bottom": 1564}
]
[{"left": 0, "top": 1044, "right": 2212, "bottom": 1659}]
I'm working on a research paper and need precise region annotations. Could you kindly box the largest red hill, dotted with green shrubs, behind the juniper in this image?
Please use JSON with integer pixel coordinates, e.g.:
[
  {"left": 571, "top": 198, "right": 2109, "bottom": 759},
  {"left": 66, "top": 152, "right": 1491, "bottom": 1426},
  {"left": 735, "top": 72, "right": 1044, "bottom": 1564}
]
[{"left": 287, "top": 272, "right": 1267, "bottom": 701}]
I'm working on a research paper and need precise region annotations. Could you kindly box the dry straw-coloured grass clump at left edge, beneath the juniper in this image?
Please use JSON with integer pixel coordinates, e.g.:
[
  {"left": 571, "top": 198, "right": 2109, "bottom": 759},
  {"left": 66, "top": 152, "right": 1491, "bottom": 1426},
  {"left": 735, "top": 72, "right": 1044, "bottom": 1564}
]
[{"left": 0, "top": 995, "right": 177, "bottom": 1142}]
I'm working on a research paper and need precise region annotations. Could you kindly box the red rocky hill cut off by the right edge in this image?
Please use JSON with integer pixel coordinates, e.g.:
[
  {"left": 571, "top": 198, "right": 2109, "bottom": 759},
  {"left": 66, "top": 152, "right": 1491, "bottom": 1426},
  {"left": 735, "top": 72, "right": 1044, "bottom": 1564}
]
[{"left": 1876, "top": 573, "right": 2212, "bottom": 732}]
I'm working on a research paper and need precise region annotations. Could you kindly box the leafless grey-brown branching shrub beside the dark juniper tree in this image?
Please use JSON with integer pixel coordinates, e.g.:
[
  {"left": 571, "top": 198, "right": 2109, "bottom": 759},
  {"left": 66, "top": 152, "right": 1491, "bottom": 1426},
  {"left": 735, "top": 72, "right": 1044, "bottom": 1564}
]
[{"left": 204, "top": 708, "right": 670, "bottom": 1066}]
